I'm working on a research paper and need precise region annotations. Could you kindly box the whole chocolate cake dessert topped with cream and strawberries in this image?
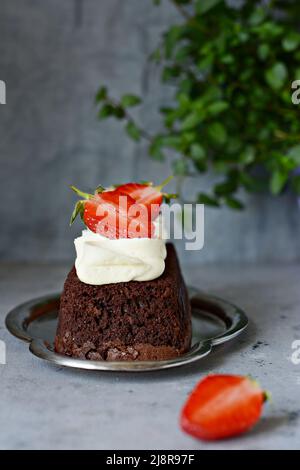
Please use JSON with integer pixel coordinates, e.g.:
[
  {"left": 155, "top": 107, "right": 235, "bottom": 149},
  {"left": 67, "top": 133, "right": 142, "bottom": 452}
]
[{"left": 55, "top": 176, "right": 191, "bottom": 361}]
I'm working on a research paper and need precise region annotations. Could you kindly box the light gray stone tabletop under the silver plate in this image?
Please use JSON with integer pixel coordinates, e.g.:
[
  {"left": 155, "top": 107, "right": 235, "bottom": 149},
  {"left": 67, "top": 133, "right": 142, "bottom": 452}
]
[{"left": 0, "top": 264, "right": 300, "bottom": 450}]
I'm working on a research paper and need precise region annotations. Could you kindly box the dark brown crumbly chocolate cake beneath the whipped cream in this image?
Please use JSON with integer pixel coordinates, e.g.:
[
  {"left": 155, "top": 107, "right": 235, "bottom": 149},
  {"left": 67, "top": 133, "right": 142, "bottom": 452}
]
[{"left": 55, "top": 244, "right": 192, "bottom": 361}]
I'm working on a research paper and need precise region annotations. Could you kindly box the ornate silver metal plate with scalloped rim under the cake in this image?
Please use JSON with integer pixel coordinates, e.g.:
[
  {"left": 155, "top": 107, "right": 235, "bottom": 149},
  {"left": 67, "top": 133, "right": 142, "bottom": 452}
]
[{"left": 6, "top": 288, "right": 248, "bottom": 372}]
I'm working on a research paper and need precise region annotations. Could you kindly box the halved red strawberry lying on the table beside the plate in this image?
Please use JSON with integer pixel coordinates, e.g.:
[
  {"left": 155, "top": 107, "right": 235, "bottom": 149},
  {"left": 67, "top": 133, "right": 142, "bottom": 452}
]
[{"left": 180, "top": 375, "right": 266, "bottom": 440}]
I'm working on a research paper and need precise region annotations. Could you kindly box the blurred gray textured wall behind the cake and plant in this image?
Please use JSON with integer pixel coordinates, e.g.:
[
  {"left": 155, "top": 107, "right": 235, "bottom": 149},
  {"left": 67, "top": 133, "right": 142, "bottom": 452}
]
[{"left": 0, "top": 0, "right": 300, "bottom": 262}]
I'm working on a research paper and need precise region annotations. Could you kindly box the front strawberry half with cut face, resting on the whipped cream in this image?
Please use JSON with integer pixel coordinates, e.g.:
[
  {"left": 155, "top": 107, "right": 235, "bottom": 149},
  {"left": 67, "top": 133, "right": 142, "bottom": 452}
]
[{"left": 83, "top": 190, "right": 154, "bottom": 239}]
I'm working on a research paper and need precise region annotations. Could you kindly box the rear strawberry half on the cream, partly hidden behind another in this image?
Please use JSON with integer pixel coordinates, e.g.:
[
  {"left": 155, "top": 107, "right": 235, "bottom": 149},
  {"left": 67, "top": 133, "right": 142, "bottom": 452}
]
[{"left": 116, "top": 176, "right": 176, "bottom": 220}]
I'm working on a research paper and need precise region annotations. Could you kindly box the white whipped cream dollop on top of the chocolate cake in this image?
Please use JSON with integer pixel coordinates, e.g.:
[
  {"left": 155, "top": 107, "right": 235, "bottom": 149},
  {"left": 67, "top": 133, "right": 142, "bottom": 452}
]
[{"left": 74, "top": 218, "right": 167, "bottom": 286}]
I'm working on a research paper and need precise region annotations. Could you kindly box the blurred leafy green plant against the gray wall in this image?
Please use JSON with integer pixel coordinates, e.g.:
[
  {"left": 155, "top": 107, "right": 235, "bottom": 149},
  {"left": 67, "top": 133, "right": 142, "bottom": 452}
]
[{"left": 96, "top": 0, "right": 300, "bottom": 209}]
